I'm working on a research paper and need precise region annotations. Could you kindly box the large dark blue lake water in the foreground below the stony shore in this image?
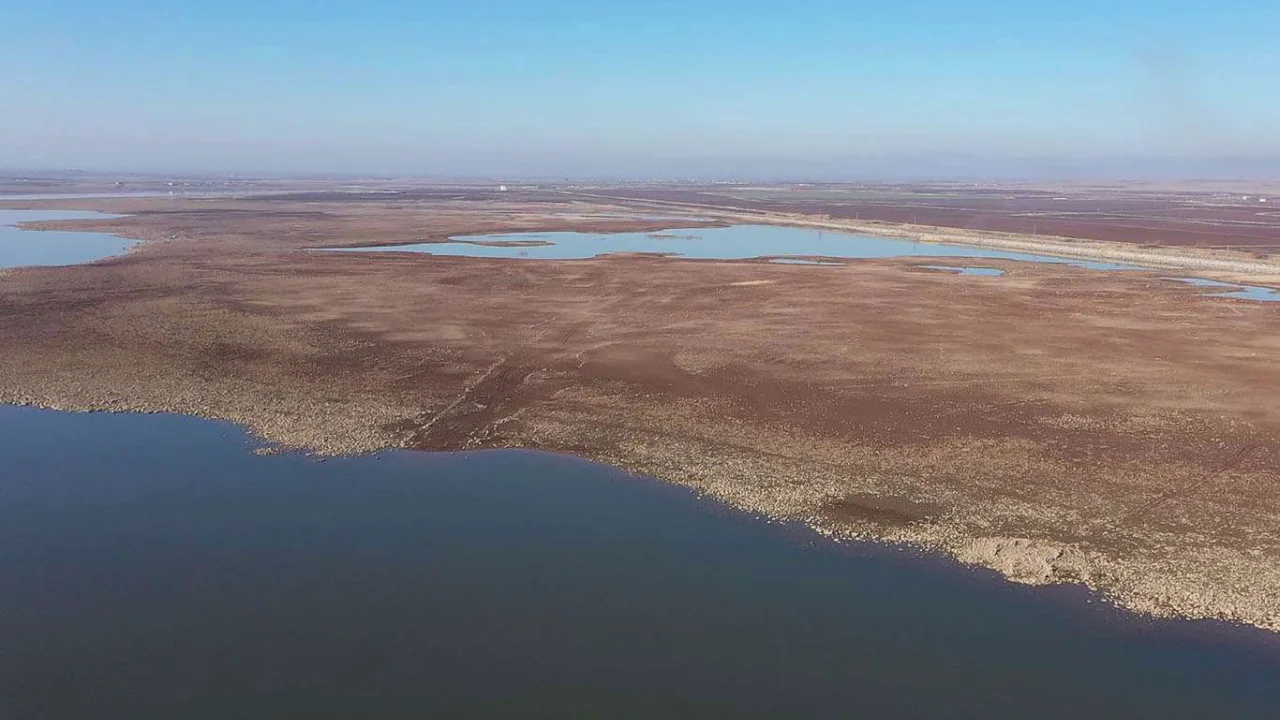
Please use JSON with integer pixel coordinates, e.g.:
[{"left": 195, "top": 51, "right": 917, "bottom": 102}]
[{"left": 0, "top": 406, "right": 1280, "bottom": 720}]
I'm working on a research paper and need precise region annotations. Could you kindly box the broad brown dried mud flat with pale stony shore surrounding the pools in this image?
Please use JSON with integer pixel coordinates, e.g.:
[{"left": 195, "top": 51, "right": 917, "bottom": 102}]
[{"left": 0, "top": 193, "right": 1280, "bottom": 630}]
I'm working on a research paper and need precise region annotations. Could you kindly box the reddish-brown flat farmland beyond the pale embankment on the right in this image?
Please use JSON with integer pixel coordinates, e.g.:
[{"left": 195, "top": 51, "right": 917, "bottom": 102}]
[{"left": 596, "top": 183, "right": 1280, "bottom": 255}]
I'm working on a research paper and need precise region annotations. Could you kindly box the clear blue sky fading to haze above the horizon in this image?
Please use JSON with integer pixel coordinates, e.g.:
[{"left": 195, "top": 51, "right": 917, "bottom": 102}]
[{"left": 0, "top": 0, "right": 1280, "bottom": 176}]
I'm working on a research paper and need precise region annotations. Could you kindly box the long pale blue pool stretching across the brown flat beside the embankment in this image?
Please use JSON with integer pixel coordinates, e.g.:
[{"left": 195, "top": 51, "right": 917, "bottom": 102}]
[{"left": 338, "top": 225, "right": 1139, "bottom": 270}]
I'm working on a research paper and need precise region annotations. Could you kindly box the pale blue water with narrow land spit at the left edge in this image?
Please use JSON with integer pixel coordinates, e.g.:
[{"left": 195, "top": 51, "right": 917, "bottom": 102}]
[{"left": 0, "top": 209, "right": 137, "bottom": 268}]
